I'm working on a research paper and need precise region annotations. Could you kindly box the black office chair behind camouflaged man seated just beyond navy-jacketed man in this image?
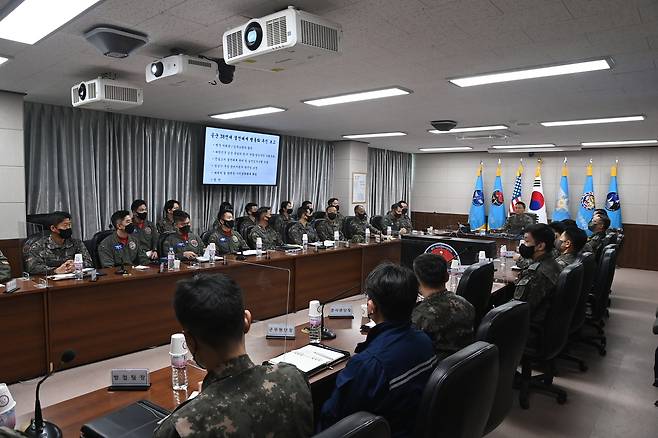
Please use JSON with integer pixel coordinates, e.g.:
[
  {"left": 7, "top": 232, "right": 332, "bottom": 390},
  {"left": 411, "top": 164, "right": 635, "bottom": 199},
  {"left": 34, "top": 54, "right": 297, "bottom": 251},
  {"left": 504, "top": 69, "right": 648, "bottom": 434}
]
[{"left": 475, "top": 300, "right": 530, "bottom": 434}]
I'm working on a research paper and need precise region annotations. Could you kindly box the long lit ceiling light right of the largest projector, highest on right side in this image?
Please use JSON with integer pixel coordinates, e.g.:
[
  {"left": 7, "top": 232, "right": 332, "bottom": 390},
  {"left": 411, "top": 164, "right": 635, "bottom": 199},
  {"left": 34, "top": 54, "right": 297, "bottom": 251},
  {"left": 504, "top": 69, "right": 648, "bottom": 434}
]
[{"left": 448, "top": 59, "right": 612, "bottom": 87}]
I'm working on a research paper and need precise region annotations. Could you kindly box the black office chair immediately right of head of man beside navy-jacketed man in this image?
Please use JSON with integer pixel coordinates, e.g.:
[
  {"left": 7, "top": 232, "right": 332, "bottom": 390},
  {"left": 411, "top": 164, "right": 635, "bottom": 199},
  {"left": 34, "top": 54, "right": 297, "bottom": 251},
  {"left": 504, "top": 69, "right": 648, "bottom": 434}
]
[{"left": 457, "top": 262, "right": 494, "bottom": 330}]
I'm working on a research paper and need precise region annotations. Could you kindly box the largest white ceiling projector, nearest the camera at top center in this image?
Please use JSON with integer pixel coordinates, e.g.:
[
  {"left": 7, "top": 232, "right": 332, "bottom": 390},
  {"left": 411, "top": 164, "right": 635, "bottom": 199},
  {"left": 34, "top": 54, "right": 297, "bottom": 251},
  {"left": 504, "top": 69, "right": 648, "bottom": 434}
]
[{"left": 222, "top": 6, "right": 343, "bottom": 71}]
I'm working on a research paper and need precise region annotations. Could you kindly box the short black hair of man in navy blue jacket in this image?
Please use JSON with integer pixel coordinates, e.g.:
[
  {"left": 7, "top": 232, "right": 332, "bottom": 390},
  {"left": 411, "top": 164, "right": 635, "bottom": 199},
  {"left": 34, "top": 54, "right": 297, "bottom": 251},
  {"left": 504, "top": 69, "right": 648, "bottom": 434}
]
[{"left": 366, "top": 263, "right": 418, "bottom": 322}]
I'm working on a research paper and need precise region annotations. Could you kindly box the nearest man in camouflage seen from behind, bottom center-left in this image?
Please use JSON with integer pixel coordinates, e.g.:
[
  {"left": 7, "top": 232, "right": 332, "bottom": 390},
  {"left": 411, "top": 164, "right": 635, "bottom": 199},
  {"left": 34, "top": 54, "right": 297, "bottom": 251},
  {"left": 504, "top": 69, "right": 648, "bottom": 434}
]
[{"left": 153, "top": 274, "right": 313, "bottom": 438}]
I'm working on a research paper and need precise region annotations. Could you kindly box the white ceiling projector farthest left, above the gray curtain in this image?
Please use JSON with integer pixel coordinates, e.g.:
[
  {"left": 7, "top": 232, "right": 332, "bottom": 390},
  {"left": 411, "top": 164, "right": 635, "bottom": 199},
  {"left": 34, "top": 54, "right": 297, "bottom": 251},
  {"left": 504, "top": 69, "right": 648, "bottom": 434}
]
[{"left": 71, "top": 78, "right": 144, "bottom": 111}]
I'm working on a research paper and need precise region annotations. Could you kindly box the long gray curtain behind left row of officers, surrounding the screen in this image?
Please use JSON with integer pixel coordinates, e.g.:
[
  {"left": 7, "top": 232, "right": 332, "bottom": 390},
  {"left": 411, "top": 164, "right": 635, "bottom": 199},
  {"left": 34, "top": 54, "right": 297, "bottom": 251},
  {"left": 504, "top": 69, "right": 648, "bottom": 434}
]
[{"left": 25, "top": 102, "right": 334, "bottom": 239}]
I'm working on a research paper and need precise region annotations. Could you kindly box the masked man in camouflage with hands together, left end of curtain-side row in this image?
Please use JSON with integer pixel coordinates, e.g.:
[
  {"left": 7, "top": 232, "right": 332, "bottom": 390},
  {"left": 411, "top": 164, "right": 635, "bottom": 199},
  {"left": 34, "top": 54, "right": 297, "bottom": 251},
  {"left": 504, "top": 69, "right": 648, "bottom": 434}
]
[{"left": 23, "top": 211, "right": 94, "bottom": 275}]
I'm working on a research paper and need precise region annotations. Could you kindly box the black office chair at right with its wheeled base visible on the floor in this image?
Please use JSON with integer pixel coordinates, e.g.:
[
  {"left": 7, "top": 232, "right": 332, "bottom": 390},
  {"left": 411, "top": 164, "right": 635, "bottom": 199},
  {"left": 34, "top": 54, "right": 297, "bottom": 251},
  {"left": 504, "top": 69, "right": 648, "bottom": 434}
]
[{"left": 517, "top": 262, "right": 583, "bottom": 409}]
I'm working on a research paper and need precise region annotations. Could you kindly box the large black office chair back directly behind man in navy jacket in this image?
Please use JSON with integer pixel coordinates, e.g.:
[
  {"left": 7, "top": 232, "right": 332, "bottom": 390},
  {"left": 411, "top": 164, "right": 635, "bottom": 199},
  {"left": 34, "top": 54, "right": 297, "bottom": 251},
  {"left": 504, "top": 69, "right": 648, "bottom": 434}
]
[{"left": 414, "top": 341, "right": 498, "bottom": 438}]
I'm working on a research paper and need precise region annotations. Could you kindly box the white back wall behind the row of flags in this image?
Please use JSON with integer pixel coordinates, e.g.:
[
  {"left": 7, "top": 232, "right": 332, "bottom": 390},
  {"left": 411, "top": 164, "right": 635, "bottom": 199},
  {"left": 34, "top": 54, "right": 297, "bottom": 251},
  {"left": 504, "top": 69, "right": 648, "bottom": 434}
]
[{"left": 411, "top": 147, "right": 658, "bottom": 225}]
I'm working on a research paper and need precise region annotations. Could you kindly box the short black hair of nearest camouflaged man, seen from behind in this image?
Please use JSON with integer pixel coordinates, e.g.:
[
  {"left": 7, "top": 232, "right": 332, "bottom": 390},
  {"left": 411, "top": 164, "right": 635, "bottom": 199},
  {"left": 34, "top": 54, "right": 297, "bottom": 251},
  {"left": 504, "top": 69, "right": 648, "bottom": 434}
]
[{"left": 174, "top": 274, "right": 244, "bottom": 348}]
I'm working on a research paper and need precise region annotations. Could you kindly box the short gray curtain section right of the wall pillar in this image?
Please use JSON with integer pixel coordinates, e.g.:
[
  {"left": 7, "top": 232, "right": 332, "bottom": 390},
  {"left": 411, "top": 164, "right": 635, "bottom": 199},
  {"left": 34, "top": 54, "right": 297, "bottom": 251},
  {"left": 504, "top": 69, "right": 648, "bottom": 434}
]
[{"left": 368, "top": 148, "right": 412, "bottom": 216}]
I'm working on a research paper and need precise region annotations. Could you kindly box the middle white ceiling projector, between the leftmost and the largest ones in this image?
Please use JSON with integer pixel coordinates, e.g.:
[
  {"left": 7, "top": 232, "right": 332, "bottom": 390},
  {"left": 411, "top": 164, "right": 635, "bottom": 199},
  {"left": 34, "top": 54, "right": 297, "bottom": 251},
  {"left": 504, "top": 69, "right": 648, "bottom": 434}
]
[{"left": 146, "top": 55, "right": 217, "bottom": 85}]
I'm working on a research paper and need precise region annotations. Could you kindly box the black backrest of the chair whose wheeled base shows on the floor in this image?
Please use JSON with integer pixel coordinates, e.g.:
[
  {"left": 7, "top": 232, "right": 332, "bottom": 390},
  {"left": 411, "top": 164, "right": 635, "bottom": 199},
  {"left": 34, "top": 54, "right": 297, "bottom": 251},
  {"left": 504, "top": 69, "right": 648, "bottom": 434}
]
[{"left": 540, "top": 262, "right": 583, "bottom": 359}]
